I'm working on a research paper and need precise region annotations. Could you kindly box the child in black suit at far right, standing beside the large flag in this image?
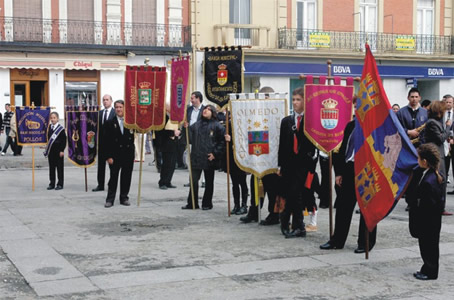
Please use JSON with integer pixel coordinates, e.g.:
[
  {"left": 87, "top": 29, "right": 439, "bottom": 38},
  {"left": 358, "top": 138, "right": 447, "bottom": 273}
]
[{"left": 405, "top": 143, "right": 444, "bottom": 280}]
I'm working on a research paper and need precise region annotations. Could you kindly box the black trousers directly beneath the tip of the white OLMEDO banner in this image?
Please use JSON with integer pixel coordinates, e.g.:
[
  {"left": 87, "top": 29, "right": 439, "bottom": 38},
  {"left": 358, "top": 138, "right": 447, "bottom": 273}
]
[{"left": 248, "top": 174, "right": 279, "bottom": 218}]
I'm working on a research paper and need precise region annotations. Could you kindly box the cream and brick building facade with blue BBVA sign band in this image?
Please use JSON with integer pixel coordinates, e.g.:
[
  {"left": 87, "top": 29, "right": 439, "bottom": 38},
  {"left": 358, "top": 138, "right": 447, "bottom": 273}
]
[{"left": 191, "top": 0, "right": 454, "bottom": 110}]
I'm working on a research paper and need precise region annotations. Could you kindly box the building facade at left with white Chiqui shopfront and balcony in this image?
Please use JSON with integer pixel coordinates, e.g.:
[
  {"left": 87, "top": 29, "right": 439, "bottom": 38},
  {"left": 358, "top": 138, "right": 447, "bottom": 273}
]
[{"left": 0, "top": 0, "right": 191, "bottom": 115}]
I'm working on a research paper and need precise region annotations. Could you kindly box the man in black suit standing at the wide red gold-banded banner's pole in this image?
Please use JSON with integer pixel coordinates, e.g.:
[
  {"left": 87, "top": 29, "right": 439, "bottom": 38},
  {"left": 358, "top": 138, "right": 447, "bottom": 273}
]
[{"left": 104, "top": 100, "right": 134, "bottom": 208}]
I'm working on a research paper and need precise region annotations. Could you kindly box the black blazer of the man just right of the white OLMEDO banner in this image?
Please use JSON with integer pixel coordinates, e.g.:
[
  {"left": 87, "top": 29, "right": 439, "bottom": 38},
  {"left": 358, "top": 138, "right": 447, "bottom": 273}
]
[{"left": 278, "top": 115, "right": 317, "bottom": 177}]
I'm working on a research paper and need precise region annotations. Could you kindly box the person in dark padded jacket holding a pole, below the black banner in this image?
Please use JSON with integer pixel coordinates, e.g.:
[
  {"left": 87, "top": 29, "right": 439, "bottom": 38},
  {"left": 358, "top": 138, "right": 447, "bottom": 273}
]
[{"left": 182, "top": 105, "right": 225, "bottom": 210}]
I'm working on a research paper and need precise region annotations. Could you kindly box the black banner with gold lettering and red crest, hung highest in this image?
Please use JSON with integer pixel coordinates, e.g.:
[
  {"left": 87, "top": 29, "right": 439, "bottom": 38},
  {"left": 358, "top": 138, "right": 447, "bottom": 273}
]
[{"left": 203, "top": 47, "right": 243, "bottom": 109}]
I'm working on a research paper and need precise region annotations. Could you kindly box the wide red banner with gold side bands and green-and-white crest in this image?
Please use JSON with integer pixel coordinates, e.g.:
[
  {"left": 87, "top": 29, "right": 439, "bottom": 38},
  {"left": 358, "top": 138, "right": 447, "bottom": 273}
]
[{"left": 125, "top": 66, "right": 166, "bottom": 133}]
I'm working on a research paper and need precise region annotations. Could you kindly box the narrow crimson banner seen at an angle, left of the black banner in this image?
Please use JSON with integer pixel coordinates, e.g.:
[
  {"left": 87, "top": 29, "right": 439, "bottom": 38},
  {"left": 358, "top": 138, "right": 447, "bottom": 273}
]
[{"left": 170, "top": 56, "right": 191, "bottom": 124}]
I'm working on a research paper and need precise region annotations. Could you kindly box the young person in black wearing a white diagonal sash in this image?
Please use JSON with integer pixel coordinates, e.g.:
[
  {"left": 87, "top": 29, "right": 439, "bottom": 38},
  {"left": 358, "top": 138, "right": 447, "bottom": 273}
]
[{"left": 46, "top": 112, "right": 66, "bottom": 190}]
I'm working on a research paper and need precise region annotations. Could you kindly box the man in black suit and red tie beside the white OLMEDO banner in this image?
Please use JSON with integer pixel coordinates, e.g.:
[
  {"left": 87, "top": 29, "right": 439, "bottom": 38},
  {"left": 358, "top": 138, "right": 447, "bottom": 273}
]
[{"left": 278, "top": 88, "right": 317, "bottom": 238}]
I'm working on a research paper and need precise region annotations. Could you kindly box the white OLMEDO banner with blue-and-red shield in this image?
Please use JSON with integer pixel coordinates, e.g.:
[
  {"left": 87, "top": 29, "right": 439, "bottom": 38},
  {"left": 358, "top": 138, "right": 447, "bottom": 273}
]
[{"left": 230, "top": 94, "right": 287, "bottom": 178}]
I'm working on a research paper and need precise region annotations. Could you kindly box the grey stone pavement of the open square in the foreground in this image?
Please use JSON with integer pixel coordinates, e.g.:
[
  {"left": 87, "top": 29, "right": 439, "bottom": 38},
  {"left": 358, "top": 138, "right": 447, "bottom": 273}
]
[{"left": 0, "top": 148, "right": 454, "bottom": 300}]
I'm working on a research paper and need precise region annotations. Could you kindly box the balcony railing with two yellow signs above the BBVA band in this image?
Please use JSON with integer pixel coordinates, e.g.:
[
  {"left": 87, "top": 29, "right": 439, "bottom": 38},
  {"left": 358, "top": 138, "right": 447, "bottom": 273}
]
[{"left": 279, "top": 28, "right": 452, "bottom": 55}]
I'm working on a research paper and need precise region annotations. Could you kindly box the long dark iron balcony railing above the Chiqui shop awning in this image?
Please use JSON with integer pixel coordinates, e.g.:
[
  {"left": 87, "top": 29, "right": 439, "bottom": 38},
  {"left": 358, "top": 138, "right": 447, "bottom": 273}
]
[{"left": 0, "top": 18, "right": 191, "bottom": 47}]
